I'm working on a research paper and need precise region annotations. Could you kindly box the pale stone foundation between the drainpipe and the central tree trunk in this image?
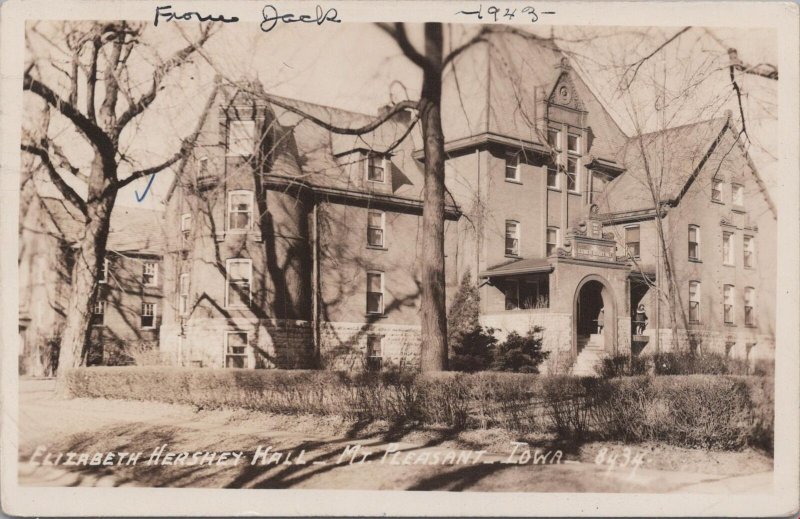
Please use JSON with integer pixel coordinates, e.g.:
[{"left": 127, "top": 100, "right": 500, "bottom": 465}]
[{"left": 320, "top": 322, "right": 421, "bottom": 371}]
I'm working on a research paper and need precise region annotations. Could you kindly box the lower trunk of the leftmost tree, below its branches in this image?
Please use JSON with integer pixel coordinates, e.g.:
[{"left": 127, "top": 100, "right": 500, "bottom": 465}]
[{"left": 56, "top": 194, "right": 116, "bottom": 395}]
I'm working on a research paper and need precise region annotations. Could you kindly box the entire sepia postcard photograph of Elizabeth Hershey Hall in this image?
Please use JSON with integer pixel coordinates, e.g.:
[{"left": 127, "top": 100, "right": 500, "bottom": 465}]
[{"left": 0, "top": 2, "right": 797, "bottom": 515}]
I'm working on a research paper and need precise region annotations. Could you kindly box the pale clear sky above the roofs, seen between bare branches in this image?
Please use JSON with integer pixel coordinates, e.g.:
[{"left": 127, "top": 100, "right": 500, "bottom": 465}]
[{"left": 25, "top": 23, "right": 778, "bottom": 209}]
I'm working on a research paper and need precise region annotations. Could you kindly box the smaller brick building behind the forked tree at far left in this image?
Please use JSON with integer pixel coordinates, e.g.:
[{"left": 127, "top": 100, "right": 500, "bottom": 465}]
[{"left": 19, "top": 194, "right": 163, "bottom": 376}]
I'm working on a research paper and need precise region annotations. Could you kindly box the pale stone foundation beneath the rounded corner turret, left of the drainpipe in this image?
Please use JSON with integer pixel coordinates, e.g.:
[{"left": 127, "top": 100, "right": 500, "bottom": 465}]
[{"left": 161, "top": 318, "right": 314, "bottom": 369}]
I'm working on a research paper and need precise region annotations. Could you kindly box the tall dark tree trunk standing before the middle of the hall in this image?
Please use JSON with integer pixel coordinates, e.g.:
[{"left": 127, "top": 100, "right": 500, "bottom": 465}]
[{"left": 419, "top": 23, "right": 447, "bottom": 371}]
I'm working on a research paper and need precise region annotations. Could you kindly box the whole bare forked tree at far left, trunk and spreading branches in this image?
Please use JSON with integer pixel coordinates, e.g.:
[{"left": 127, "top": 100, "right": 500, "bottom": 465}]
[{"left": 21, "top": 22, "right": 213, "bottom": 387}]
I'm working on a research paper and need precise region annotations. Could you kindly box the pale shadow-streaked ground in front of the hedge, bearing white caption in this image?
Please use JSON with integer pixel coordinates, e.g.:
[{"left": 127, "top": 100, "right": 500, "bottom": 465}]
[{"left": 19, "top": 381, "right": 772, "bottom": 493}]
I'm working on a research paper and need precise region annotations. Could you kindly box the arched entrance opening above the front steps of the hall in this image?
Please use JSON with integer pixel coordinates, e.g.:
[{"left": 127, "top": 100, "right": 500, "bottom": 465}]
[{"left": 572, "top": 275, "right": 617, "bottom": 355}]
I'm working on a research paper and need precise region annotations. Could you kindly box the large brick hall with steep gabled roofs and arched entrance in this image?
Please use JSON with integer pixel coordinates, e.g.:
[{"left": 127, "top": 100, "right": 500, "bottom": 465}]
[{"left": 160, "top": 34, "right": 776, "bottom": 369}]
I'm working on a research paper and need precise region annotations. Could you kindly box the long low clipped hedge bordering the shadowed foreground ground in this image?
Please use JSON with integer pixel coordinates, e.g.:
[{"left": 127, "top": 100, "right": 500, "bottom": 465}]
[{"left": 67, "top": 366, "right": 774, "bottom": 451}]
